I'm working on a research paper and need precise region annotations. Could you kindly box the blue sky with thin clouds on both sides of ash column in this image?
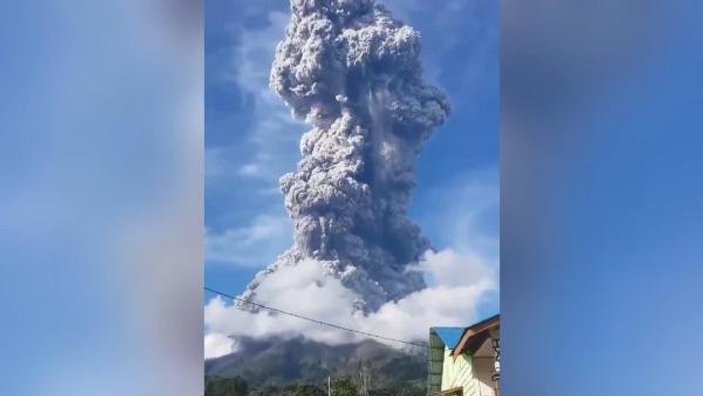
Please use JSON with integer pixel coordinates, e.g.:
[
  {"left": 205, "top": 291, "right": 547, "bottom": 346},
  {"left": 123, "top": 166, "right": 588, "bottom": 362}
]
[{"left": 205, "top": 0, "right": 498, "bottom": 318}]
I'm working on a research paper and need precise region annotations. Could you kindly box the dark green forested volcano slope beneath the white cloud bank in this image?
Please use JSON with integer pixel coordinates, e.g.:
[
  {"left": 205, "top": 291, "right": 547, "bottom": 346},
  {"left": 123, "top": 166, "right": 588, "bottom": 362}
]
[{"left": 205, "top": 338, "right": 427, "bottom": 396}]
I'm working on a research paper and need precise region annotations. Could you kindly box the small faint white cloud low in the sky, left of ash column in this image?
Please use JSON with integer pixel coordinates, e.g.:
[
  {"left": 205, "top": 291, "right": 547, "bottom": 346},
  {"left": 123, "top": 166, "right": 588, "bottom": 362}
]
[{"left": 205, "top": 214, "right": 292, "bottom": 267}]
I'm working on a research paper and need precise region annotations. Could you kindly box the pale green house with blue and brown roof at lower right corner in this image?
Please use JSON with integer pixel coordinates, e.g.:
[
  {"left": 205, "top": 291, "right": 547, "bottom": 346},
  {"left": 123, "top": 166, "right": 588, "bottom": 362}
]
[{"left": 427, "top": 315, "right": 500, "bottom": 396}]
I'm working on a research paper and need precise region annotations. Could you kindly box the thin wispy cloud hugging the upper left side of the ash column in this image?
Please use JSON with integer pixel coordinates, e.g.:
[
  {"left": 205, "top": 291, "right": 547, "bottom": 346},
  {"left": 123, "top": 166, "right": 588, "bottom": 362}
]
[{"left": 206, "top": 11, "right": 305, "bottom": 184}]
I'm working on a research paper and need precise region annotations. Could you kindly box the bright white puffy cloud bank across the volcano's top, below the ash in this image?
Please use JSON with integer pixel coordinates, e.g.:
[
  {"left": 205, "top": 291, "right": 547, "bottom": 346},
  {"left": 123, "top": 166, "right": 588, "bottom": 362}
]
[{"left": 205, "top": 250, "right": 497, "bottom": 356}]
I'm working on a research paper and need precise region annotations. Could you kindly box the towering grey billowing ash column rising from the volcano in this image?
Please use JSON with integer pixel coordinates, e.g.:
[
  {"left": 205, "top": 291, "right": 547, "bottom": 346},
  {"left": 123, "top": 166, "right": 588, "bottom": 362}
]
[{"left": 244, "top": 0, "right": 449, "bottom": 312}]
